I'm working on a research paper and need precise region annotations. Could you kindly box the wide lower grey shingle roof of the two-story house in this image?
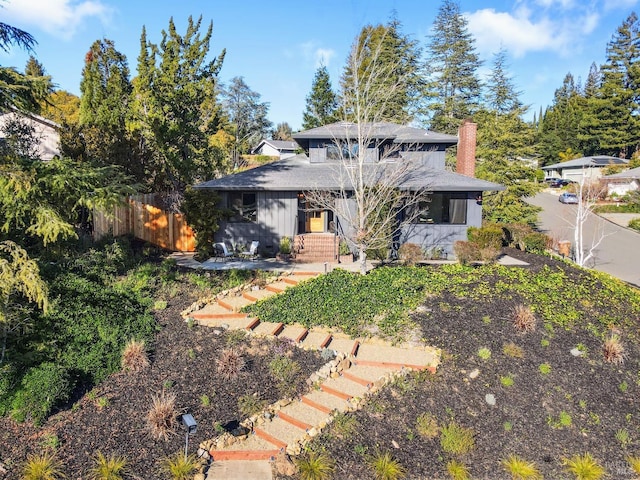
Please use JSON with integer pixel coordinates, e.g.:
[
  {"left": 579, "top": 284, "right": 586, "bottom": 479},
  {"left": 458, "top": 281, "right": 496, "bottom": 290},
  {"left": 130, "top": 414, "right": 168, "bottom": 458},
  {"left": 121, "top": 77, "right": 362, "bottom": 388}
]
[{"left": 193, "top": 154, "right": 504, "bottom": 192}]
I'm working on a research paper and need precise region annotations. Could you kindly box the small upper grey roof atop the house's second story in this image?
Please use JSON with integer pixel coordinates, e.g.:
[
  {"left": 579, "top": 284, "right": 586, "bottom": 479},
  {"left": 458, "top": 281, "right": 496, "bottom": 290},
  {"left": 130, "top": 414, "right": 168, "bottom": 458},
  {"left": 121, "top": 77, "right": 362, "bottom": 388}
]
[{"left": 293, "top": 122, "right": 458, "bottom": 150}]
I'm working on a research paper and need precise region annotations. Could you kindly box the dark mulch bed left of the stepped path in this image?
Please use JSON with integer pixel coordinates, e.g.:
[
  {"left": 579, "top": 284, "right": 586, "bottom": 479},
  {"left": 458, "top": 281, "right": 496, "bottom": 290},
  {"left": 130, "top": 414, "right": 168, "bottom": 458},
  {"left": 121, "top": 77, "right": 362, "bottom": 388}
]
[{"left": 0, "top": 284, "right": 324, "bottom": 480}]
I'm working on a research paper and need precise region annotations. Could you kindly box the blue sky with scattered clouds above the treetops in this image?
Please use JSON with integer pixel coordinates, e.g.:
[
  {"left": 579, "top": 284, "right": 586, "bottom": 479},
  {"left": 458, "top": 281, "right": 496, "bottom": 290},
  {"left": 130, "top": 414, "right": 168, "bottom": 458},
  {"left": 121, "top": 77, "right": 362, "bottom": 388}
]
[{"left": 0, "top": 0, "right": 640, "bottom": 130}]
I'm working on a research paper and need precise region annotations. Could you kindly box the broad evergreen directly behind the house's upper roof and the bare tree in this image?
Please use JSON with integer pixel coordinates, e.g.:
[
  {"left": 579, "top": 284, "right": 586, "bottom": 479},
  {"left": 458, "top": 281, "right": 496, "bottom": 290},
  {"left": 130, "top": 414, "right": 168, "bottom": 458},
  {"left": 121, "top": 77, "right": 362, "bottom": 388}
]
[{"left": 341, "top": 19, "right": 421, "bottom": 124}]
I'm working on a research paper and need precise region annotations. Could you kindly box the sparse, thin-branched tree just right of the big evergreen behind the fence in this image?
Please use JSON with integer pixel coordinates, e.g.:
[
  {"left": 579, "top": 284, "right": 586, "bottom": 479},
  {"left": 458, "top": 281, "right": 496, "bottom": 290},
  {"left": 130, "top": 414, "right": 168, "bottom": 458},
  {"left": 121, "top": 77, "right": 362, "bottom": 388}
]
[{"left": 224, "top": 77, "right": 272, "bottom": 168}]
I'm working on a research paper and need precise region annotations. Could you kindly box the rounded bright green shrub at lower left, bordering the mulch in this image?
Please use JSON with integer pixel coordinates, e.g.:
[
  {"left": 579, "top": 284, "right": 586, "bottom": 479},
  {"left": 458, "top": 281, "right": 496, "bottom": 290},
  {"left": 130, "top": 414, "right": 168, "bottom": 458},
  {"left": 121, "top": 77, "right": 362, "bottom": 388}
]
[{"left": 11, "top": 362, "right": 73, "bottom": 425}]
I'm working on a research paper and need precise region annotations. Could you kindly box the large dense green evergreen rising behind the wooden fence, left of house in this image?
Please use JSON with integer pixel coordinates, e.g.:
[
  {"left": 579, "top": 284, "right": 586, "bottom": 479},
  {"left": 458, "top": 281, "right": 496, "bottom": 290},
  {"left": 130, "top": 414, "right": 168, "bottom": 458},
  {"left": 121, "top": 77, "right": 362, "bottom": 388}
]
[{"left": 132, "top": 17, "right": 225, "bottom": 195}]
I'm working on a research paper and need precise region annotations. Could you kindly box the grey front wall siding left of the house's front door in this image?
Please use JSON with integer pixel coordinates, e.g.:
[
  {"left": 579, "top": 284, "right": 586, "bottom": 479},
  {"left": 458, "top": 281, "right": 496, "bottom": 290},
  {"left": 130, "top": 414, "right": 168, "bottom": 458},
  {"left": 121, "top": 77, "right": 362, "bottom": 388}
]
[{"left": 215, "top": 191, "right": 298, "bottom": 253}]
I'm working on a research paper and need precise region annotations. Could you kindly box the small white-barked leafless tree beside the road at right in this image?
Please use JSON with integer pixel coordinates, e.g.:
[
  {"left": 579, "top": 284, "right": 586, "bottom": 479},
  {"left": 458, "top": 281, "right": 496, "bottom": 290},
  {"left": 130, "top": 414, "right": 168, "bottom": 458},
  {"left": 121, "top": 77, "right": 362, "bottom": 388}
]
[{"left": 573, "top": 171, "right": 606, "bottom": 267}]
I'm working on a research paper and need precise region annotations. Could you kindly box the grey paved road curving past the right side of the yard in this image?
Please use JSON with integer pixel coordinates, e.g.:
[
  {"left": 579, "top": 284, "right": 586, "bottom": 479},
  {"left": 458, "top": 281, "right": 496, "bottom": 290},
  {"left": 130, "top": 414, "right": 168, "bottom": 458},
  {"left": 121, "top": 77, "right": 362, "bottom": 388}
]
[{"left": 529, "top": 193, "right": 640, "bottom": 286}]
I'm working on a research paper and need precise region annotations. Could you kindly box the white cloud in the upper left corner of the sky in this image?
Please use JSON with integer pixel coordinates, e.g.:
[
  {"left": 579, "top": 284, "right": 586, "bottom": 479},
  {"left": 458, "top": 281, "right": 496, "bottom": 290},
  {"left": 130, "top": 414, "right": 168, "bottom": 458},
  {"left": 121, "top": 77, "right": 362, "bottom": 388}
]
[{"left": 2, "top": 0, "right": 113, "bottom": 40}]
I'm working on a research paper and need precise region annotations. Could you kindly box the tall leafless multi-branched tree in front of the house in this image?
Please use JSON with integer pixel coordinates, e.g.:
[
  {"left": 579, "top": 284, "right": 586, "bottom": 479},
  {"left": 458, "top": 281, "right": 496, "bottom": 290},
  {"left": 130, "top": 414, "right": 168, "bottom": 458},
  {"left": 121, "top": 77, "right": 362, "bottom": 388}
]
[{"left": 305, "top": 31, "right": 429, "bottom": 273}]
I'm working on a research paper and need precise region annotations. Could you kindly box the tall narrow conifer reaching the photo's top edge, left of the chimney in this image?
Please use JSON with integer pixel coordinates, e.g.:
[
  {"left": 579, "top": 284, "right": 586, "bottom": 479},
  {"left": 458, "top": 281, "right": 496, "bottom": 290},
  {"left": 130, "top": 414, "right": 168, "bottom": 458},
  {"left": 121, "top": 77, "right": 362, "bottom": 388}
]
[{"left": 426, "top": 0, "right": 482, "bottom": 134}]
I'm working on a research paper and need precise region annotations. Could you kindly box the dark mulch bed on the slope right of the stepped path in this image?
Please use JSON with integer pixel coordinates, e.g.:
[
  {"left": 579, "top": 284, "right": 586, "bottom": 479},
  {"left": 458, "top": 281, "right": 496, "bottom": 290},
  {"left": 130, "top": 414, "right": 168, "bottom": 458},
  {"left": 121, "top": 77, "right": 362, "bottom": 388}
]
[{"left": 296, "top": 250, "right": 640, "bottom": 480}]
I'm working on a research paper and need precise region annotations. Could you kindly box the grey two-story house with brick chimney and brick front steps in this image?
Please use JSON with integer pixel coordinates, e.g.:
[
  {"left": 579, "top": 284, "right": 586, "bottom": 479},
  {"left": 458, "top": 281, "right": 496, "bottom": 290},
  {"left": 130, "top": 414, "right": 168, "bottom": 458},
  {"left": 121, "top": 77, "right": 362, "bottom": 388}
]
[{"left": 194, "top": 122, "right": 504, "bottom": 261}]
